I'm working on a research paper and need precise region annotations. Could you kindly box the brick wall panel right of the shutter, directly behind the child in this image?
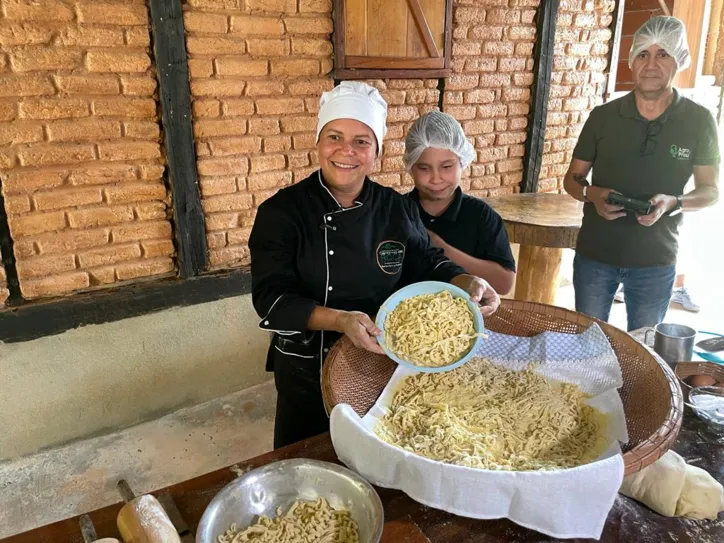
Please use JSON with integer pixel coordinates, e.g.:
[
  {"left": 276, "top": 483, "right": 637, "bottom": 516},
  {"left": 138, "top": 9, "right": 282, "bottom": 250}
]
[{"left": 443, "top": 0, "right": 540, "bottom": 197}]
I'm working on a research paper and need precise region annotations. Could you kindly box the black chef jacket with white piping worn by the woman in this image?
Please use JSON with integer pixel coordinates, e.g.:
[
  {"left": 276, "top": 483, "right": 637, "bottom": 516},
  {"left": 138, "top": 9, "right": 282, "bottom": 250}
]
[{"left": 249, "top": 171, "right": 465, "bottom": 371}]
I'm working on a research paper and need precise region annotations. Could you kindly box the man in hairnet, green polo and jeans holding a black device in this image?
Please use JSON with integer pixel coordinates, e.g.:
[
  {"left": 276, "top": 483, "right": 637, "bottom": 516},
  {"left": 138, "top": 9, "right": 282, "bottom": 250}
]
[{"left": 564, "top": 17, "right": 719, "bottom": 330}]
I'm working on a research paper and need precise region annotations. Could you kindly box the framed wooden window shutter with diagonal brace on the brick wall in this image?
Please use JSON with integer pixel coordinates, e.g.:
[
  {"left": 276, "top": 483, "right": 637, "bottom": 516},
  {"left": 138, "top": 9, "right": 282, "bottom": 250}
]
[{"left": 334, "top": 0, "right": 452, "bottom": 79}]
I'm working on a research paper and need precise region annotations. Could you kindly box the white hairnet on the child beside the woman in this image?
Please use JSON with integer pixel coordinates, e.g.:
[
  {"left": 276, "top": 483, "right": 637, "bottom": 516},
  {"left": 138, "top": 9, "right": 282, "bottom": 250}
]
[{"left": 405, "top": 111, "right": 476, "bottom": 171}]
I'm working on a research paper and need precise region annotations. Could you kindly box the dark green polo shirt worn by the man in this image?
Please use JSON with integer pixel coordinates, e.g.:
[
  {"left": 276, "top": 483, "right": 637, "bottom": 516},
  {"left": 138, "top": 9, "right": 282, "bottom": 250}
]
[{"left": 573, "top": 90, "right": 719, "bottom": 268}]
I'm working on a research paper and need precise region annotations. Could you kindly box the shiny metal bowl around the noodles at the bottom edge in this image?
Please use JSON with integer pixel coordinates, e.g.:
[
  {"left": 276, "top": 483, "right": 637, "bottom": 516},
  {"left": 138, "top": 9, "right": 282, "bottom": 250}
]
[{"left": 196, "top": 458, "right": 384, "bottom": 543}]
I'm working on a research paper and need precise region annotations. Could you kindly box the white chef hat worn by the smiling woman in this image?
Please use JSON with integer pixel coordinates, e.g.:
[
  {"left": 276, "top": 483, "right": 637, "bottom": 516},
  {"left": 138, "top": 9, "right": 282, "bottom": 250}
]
[{"left": 316, "top": 81, "right": 387, "bottom": 156}]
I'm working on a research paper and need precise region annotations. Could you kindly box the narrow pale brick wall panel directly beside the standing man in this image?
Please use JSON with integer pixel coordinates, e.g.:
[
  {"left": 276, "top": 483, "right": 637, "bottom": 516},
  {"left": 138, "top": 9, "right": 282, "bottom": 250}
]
[{"left": 538, "top": 0, "right": 615, "bottom": 192}]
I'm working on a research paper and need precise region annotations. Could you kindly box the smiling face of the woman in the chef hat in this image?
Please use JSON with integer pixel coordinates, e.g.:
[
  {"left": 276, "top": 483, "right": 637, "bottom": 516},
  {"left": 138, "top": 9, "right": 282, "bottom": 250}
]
[{"left": 317, "top": 119, "right": 377, "bottom": 192}]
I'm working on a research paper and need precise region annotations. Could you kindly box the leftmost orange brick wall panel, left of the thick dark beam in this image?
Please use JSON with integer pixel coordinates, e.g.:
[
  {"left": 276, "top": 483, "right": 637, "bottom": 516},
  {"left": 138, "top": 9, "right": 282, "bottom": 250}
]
[{"left": 0, "top": 0, "right": 174, "bottom": 298}]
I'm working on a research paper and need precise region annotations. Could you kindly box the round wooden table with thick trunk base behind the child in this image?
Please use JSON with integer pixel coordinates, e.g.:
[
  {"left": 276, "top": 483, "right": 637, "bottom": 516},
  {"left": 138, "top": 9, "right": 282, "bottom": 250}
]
[{"left": 485, "top": 193, "right": 583, "bottom": 304}]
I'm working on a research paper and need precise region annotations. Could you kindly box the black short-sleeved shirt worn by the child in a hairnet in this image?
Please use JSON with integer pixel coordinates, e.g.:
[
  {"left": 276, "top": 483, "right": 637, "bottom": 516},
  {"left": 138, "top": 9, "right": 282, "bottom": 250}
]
[{"left": 408, "top": 187, "right": 515, "bottom": 271}]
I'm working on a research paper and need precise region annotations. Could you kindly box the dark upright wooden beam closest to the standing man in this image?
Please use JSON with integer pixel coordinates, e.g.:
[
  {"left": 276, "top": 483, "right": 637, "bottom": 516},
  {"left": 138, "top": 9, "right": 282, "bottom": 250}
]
[{"left": 520, "top": 0, "right": 559, "bottom": 196}]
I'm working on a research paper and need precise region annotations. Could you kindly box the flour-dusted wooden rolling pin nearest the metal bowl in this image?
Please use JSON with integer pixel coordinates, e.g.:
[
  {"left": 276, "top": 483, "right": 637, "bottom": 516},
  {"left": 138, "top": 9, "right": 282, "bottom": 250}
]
[{"left": 116, "top": 480, "right": 181, "bottom": 543}]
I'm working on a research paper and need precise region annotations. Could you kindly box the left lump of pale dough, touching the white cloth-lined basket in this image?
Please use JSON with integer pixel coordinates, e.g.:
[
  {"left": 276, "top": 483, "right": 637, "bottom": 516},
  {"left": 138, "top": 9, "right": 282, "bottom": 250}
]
[{"left": 620, "top": 451, "right": 686, "bottom": 517}]
